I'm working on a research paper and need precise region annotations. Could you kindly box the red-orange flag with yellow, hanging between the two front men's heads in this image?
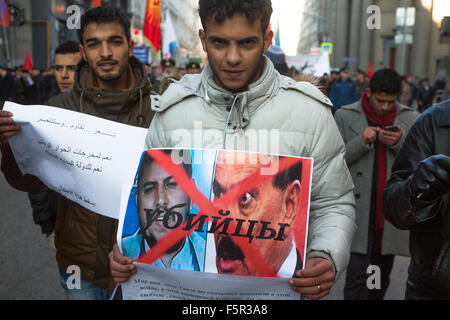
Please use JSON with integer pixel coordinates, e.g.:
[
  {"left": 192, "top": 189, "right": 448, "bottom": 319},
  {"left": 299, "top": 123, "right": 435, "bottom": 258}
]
[{"left": 144, "top": 0, "right": 161, "bottom": 57}]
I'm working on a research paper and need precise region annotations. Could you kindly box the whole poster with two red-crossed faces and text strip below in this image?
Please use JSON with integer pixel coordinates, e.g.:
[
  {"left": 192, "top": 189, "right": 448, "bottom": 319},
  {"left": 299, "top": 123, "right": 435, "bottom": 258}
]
[{"left": 117, "top": 149, "right": 313, "bottom": 300}]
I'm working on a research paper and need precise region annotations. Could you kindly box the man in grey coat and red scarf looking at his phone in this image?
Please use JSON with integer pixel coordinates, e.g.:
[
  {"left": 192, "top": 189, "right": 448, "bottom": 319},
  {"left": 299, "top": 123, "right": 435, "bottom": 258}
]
[{"left": 335, "top": 69, "right": 419, "bottom": 300}]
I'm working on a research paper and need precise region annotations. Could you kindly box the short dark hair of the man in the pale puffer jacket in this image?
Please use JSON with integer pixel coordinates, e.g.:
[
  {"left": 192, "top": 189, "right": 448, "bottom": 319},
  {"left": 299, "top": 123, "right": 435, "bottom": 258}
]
[{"left": 199, "top": 0, "right": 273, "bottom": 33}]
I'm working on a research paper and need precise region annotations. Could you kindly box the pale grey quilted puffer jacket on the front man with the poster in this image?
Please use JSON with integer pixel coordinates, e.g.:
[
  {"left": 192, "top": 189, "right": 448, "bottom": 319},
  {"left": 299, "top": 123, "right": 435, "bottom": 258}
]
[{"left": 146, "top": 58, "right": 355, "bottom": 277}]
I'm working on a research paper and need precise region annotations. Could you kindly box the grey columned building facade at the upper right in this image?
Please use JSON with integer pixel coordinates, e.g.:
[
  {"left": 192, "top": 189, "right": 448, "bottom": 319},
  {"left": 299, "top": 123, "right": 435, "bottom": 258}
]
[{"left": 299, "top": 0, "right": 450, "bottom": 79}]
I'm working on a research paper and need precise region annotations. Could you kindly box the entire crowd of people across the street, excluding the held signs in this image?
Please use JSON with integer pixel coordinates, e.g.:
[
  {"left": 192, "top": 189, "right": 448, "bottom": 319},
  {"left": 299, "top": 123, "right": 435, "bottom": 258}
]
[{"left": 0, "top": 0, "right": 450, "bottom": 299}]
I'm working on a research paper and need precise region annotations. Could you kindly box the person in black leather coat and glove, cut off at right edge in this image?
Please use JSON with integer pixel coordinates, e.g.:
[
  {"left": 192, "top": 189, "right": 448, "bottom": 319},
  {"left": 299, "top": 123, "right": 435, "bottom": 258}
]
[{"left": 384, "top": 100, "right": 450, "bottom": 300}]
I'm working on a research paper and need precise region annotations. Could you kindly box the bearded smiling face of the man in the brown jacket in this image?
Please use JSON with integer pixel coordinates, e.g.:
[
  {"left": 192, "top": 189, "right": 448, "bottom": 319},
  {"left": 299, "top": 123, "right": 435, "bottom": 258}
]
[{"left": 81, "top": 22, "right": 134, "bottom": 82}]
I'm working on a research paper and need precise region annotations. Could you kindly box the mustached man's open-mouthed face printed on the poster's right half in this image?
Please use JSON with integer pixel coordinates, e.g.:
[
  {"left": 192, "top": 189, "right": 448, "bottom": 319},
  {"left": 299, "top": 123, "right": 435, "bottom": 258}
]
[{"left": 213, "top": 151, "right": 300, "bottom": 276}]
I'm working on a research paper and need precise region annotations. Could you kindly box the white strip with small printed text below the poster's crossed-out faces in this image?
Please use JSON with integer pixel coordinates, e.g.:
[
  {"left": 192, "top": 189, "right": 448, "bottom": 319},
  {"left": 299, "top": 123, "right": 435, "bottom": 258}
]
[{"left": 122, "top": 263, "right": 300, "bottom": 300}]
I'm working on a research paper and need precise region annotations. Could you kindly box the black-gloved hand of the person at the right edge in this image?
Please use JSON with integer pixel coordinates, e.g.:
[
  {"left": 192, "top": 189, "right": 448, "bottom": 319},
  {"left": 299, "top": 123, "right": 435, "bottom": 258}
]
[{"left": 411, "top": 154, "right": 450, "bottom": 201}]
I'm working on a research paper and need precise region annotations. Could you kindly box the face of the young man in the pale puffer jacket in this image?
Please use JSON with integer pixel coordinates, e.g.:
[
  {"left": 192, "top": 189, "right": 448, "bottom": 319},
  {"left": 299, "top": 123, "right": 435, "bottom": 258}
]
[{"left": 199, "top": 13, "right": 273, "bottom": 93}]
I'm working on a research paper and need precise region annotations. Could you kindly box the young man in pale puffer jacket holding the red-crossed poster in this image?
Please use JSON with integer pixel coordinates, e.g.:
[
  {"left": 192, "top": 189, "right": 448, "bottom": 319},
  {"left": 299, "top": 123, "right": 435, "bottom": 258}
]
[{"left": 110, "top": 0, "right": 355, "bottom": 299}]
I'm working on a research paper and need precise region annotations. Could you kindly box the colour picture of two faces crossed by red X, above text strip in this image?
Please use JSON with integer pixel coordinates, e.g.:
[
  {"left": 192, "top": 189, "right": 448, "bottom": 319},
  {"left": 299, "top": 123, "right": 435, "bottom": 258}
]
[{"left": 121, "top": 150, "right": 312, "bottom": 277}]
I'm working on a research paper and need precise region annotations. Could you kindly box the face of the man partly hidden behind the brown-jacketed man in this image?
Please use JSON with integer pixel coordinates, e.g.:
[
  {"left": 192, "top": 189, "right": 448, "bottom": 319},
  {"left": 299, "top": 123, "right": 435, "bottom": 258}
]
[{"left": 54, "top": 52, "right": 81, "bottom": 92}]
